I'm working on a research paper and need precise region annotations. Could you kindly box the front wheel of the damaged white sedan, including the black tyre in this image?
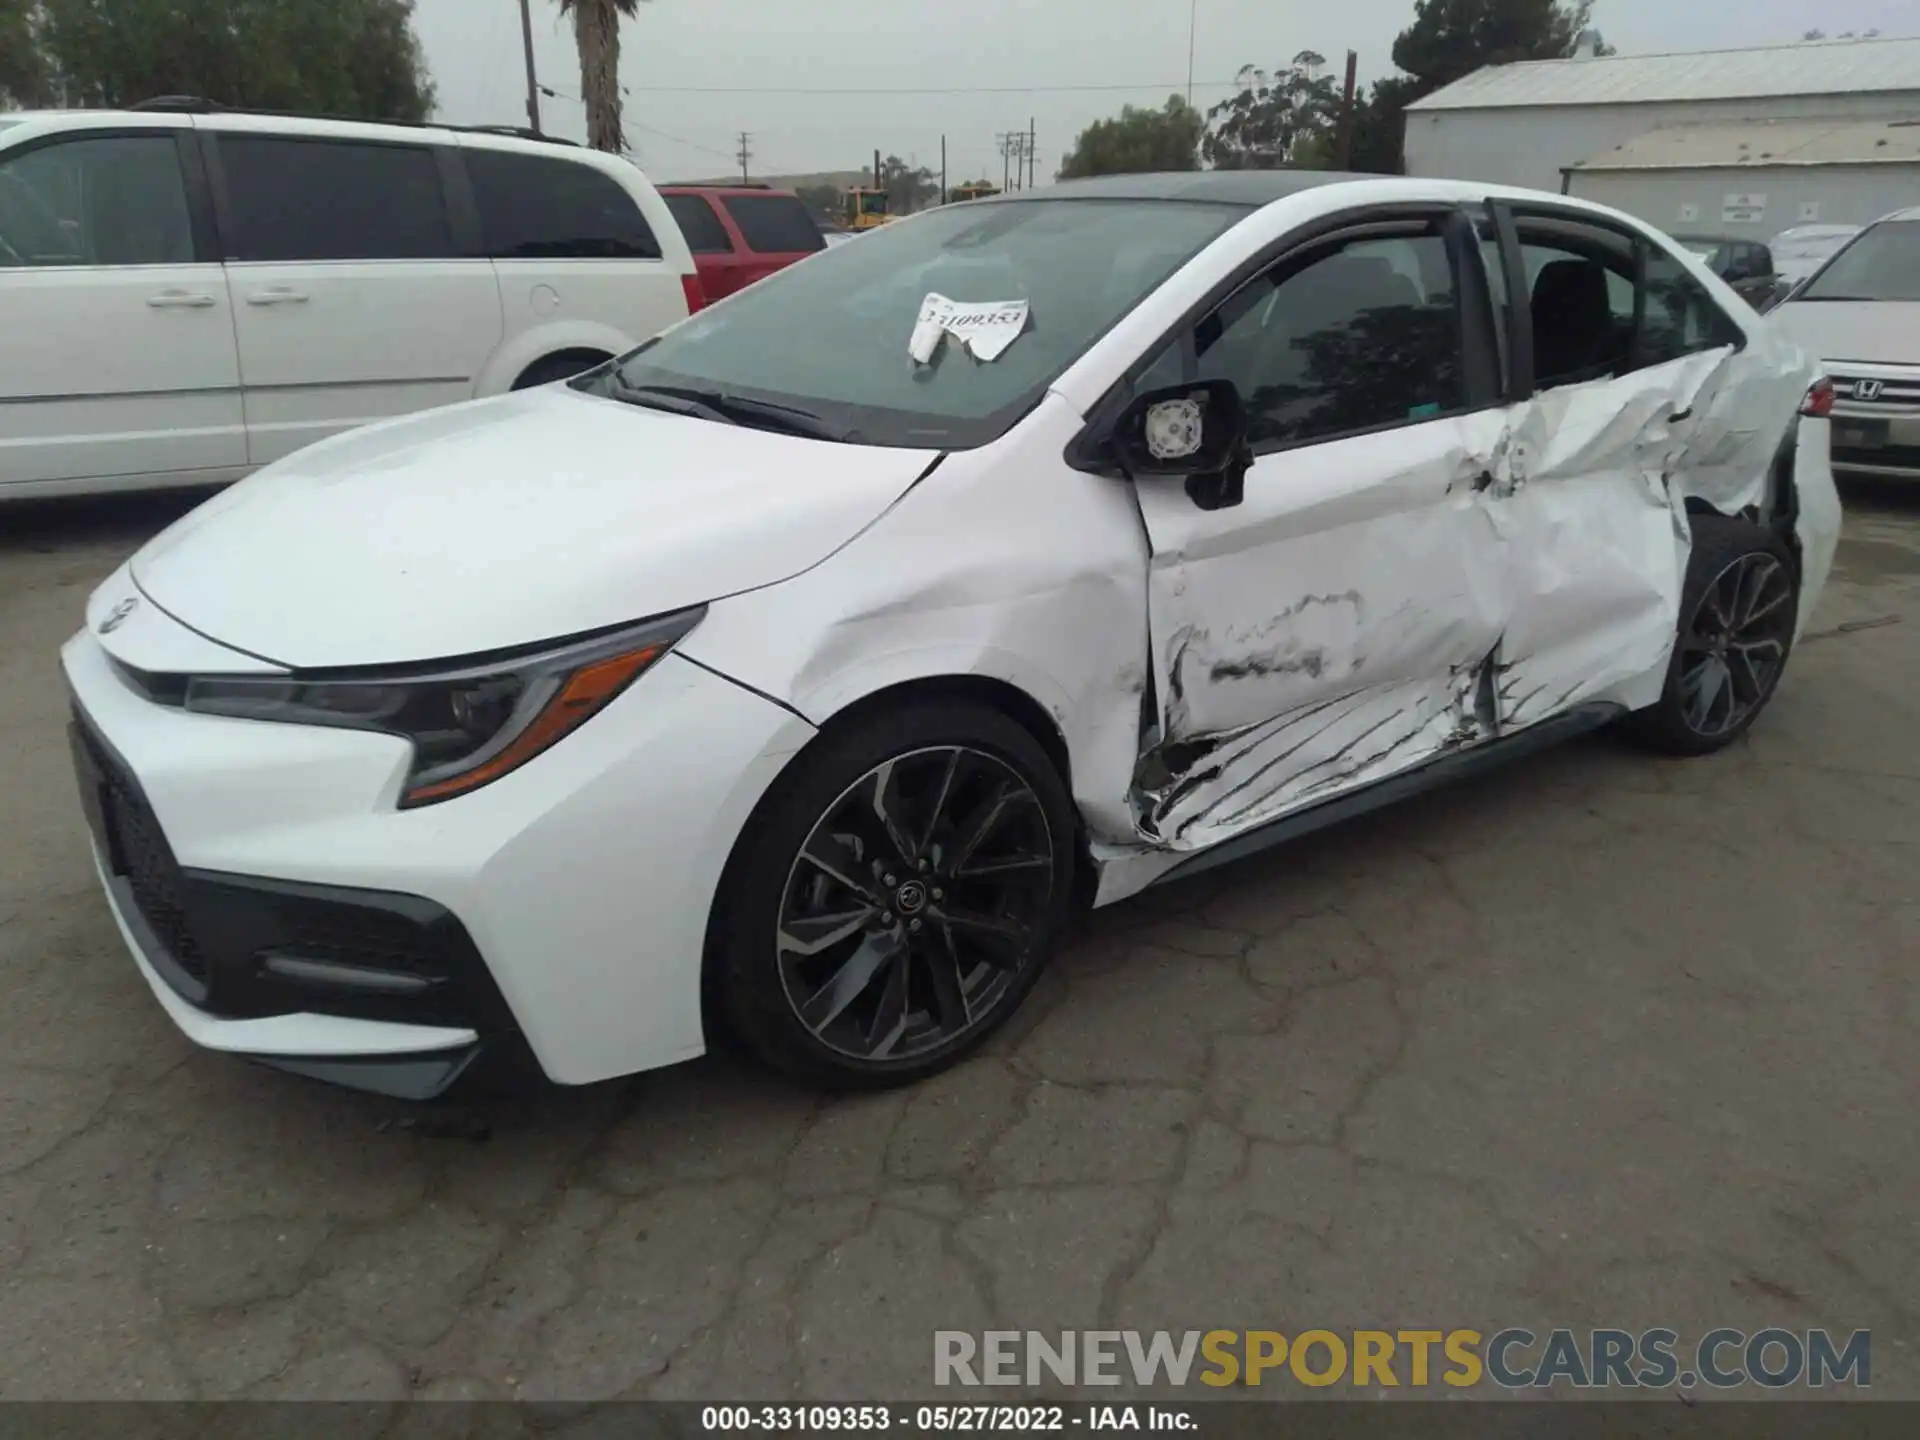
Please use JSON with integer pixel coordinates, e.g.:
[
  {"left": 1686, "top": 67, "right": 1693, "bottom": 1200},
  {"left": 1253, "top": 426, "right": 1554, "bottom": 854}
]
[{"left": 712, "top": 703, "right": 1075, "bottom": 1087}]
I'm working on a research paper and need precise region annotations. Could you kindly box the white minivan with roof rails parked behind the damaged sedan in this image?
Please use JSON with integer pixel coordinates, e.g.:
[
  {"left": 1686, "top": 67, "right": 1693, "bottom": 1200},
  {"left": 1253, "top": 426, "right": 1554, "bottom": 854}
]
[{"left": 0, "top": 102, "right": 701, "bottom": 501}]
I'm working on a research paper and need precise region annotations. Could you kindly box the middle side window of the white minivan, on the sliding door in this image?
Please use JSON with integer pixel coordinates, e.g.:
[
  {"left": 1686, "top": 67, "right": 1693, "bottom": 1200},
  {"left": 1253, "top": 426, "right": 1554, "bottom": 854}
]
[{"left": 219, "top": 134, "right": 457, "bottom": 261}]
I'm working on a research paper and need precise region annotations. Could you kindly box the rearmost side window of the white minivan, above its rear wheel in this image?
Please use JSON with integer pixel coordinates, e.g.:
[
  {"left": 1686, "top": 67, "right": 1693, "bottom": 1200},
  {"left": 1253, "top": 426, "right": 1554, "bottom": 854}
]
[{"left": 467, "top": 148, "right": 660, "bottom": 259}]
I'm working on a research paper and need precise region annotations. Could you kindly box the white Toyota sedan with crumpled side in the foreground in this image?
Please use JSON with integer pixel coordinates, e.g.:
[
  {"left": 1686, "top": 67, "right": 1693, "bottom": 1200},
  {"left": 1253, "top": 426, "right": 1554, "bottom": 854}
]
[{"left": 63, "top": 173, "right": 1839, "bottom": 1096}]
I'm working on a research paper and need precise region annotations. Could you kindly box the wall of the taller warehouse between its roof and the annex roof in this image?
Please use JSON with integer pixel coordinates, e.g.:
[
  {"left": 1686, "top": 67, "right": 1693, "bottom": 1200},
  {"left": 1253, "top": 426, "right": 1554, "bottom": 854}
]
[{"left": 1407, "top": 88, "right": 1920, "bottom": 190}]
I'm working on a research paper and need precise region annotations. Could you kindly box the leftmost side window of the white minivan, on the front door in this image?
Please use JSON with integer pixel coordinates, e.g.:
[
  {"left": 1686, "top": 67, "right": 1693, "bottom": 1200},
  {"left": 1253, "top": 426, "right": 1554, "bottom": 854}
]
[{"left": 0, "top": 134, "right": 194, "bottom": 267}]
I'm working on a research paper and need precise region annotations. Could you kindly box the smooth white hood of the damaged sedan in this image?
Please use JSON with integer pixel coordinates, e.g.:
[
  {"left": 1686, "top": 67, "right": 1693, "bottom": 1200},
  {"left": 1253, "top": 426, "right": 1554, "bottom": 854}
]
[{"left": 132, "top": 386, "right": 935, "bottom": 668}]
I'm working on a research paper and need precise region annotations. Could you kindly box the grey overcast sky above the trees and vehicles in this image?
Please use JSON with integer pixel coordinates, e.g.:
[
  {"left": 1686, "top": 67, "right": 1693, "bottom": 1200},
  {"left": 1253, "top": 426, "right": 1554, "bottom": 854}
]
[{"left": 415, "top": 0, "right": 1920, "bottom": 184}]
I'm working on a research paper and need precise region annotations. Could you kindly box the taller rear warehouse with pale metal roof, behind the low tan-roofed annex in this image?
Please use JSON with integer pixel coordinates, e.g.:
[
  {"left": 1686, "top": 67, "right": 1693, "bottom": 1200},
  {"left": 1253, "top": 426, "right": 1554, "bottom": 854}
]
[{"left": 1405, "top": 38, "right": 1920, "bottom": 204}]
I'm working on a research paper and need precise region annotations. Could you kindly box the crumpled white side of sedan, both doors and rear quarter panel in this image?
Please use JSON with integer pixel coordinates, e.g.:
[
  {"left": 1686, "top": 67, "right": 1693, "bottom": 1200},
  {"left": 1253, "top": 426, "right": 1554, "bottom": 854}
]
[{"left": 1135, "top": 332, "right": 1818, "bottom": 867}]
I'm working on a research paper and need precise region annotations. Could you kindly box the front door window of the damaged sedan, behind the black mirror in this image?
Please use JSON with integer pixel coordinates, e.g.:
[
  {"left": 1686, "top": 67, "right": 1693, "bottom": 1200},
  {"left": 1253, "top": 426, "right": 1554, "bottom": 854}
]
[{"left": 1194, "top": 234, "right": 1465, "bottom": 449}]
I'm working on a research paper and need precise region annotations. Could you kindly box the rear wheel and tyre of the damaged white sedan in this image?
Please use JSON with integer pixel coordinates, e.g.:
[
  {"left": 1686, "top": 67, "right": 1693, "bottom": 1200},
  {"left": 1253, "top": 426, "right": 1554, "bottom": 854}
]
[{"left": 1626, "top": 515, "right": 1799, "bottom": 755}]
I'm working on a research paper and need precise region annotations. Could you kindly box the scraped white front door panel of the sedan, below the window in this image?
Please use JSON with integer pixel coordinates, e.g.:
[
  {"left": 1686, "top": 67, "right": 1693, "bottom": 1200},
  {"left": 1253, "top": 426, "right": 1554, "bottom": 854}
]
[{"left": 1135, "top": 411, "right": 1515, "bottom": 851}]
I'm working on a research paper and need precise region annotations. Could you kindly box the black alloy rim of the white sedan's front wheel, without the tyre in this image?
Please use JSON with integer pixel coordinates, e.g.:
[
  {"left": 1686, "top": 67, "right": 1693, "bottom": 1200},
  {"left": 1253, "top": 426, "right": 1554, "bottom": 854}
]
[{"left": 774, "top": 745, "right": 1056, "bottom": 1062}]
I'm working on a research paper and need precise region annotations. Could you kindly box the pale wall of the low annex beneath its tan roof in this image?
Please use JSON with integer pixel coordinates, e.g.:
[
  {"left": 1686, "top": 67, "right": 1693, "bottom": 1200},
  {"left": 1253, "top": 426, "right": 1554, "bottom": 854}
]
[{"left": 1571, "top": 165, "right": 1920, "bottom": 242}]
